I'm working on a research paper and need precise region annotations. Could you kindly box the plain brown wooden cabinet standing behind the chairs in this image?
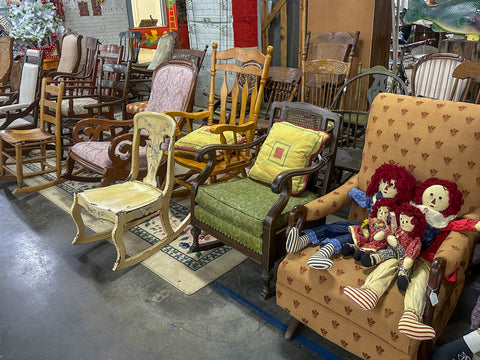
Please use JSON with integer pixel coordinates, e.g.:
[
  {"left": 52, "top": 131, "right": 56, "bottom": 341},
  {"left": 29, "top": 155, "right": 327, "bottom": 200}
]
[{"left": 307, "top": 0, "right": 392, "bottom": 72}]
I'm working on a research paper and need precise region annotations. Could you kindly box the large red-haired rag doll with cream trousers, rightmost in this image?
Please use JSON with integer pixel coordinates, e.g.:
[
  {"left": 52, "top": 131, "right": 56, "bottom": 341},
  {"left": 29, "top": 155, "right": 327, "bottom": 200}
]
[{"left": 344, "top": 178, "right": 480, "bottom": 340}]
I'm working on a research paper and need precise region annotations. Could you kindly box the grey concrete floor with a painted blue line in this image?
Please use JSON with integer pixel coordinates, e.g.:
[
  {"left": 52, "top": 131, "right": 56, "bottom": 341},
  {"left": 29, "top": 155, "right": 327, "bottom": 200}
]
[{"left": 0, "top": 181, "right": 480, "bottom": 360}]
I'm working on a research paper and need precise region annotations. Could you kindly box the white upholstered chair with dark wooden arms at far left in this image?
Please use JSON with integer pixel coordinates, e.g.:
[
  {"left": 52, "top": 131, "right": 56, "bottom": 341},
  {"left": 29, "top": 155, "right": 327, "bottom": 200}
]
[{"left": 0, "top": 49, "right": 42, "bottom": 130}]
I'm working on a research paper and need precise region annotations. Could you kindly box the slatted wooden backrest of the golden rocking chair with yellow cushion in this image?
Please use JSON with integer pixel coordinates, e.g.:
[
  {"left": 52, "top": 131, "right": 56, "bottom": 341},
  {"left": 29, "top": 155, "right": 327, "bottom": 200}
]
[{"left": 207, "top": 42, "right": 273, "bottom": 141}]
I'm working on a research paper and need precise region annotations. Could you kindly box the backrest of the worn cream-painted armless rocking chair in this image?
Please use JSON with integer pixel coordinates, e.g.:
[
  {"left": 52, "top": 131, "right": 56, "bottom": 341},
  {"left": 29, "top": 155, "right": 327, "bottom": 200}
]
[{"left": 130, "top": 111, "right": 177, "bottom": 190}]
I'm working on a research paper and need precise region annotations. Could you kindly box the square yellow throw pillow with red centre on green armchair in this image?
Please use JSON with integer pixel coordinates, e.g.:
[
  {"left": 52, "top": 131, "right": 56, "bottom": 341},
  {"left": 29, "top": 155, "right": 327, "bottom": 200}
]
[{"left": 249, "top": 121, "right": 329, "bottom": 194}]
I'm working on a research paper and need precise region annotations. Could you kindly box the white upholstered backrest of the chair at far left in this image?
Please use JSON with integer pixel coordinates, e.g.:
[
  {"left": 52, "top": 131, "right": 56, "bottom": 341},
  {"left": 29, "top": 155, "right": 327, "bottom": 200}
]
[{"left": 18, "top": 49, "right": 43, "bottom": 104}]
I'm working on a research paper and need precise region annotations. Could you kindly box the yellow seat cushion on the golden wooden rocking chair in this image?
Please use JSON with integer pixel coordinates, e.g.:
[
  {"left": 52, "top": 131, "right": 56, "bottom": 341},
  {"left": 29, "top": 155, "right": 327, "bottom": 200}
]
[{"left": 175, "top": 126, "right": 242, "bottom": 157}]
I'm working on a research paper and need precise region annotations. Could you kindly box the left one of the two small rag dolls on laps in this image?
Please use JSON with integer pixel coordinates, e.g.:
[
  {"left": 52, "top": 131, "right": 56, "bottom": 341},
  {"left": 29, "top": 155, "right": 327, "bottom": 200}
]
[{"left": 342, "top": 198, "right": 397, "bottom": 260}]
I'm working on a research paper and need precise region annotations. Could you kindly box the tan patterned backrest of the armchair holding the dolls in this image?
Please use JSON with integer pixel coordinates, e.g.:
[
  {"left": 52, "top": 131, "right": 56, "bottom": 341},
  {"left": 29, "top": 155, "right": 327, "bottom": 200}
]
[{"left": 350, "top": 93, "right": 480, "bottom": 221}]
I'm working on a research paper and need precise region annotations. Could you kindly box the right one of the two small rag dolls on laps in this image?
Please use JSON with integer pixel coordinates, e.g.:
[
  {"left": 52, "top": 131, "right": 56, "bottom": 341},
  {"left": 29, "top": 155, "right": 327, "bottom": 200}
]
[{"left": 360, "top": 203, "right": 426, "bottom": 290}]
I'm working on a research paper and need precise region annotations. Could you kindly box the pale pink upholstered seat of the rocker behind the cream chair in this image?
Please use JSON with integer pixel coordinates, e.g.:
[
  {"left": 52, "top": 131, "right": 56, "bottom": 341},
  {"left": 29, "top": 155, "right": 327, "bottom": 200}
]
[{"left": 70, "top": 141, "right": 147, "bottom": 169}]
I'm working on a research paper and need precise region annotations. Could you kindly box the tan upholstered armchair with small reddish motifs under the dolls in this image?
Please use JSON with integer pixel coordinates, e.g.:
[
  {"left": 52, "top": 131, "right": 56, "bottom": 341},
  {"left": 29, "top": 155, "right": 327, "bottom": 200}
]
[{"left": 276, "top": 93, "right": 480, "bottom": 360}]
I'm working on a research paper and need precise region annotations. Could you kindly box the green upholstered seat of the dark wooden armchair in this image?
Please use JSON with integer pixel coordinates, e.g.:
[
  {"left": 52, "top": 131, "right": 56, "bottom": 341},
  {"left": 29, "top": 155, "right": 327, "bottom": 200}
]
[{"left": 194, "top": 178, "right": 317, "bottom": 254}]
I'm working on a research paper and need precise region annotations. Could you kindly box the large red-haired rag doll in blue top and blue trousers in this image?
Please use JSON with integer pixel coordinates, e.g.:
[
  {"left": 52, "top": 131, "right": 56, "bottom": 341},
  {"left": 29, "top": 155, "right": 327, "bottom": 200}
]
[{"left": 286, "top": 163, "right": 415, "bottom": 270}]
